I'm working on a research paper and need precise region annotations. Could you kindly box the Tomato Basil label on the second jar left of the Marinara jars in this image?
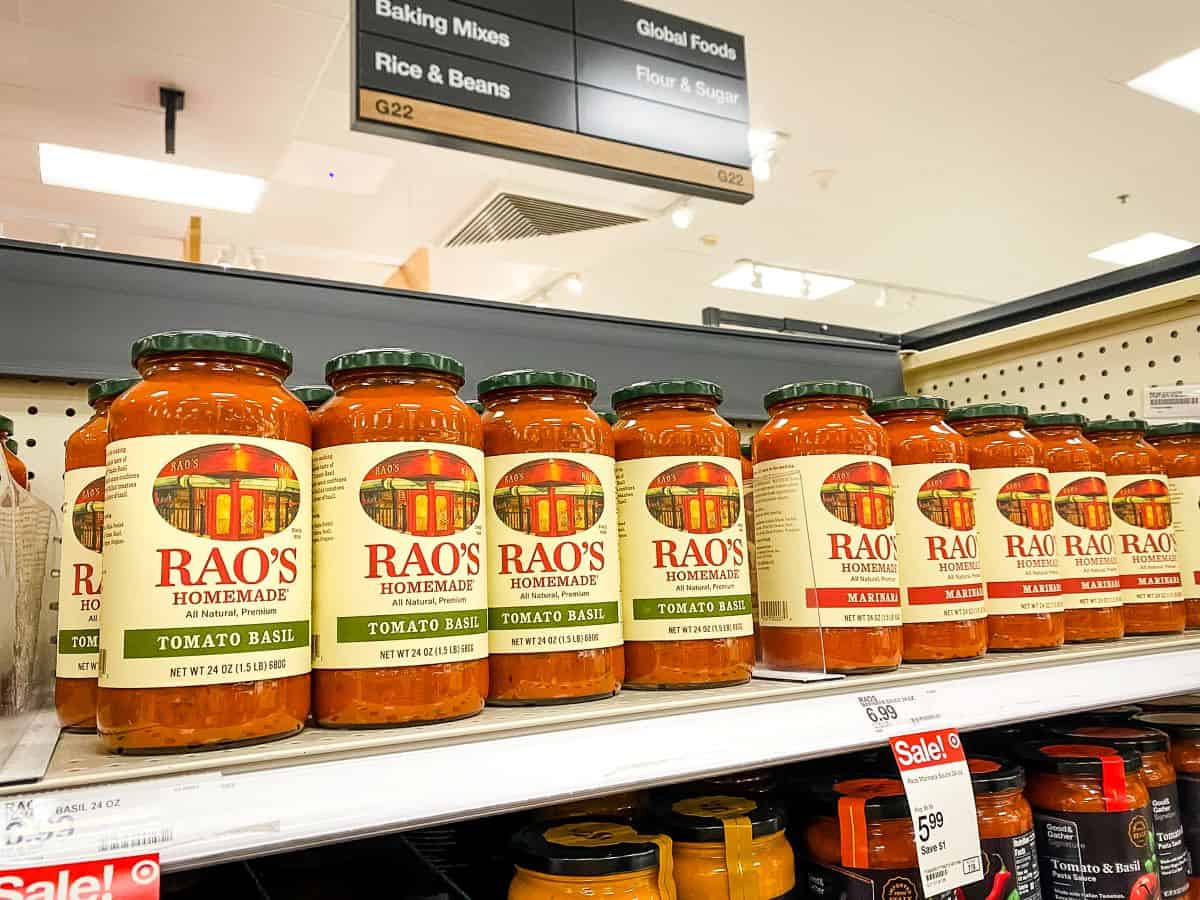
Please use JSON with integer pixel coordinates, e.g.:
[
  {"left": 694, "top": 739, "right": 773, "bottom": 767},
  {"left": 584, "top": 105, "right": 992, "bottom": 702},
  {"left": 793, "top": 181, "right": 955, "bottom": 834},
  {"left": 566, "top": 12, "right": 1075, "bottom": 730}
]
[{"left": 484, "top": 452, "right": 622, "bottom": 653}]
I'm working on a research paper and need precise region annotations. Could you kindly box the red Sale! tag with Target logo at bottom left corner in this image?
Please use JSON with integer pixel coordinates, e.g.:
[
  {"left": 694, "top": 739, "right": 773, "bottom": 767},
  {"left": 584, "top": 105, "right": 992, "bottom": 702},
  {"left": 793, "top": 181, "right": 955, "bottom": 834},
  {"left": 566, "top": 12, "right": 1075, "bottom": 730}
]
[{"left": 0, "top": 853, "right": 158, "bottom": 900}]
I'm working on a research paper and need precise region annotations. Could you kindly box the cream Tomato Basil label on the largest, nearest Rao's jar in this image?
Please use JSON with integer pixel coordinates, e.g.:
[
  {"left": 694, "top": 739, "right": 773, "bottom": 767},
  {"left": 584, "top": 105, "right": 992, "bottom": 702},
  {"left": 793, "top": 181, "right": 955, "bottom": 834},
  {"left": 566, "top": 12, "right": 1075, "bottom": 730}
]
[{"left": 100, "top": 434, "right": 312, "bottom": 688}]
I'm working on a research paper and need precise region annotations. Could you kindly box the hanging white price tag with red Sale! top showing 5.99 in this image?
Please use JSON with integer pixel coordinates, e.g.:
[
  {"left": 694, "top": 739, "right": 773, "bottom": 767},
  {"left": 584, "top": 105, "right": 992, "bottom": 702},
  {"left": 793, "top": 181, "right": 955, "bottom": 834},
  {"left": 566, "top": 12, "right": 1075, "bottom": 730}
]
[{"left": 890, "top": 728, "right": 983, "bottom": 898}]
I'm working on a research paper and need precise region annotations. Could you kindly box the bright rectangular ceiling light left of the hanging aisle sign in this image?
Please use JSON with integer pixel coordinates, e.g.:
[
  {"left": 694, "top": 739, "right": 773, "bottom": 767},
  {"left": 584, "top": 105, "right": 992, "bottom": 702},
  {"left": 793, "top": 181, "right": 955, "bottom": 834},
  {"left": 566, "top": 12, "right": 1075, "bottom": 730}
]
[{"left": 37, "top": 144, "right": 266, "bottom": 212}]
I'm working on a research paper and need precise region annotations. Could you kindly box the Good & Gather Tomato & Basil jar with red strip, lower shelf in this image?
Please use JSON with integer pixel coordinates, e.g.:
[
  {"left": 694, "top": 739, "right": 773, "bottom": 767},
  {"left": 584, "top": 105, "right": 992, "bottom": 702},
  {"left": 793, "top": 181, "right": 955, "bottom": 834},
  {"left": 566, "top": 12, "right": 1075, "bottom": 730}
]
[{"left": 1018, "top": 739, "right": 1160, "bottom": 900}]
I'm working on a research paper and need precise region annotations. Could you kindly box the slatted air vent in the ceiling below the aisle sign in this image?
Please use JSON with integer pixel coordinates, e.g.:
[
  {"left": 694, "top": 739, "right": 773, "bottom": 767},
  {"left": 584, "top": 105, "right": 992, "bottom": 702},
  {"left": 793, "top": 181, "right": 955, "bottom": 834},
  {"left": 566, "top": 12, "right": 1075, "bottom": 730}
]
[{"left": 446, "top": 192, "right": 646, "bottom": 247}]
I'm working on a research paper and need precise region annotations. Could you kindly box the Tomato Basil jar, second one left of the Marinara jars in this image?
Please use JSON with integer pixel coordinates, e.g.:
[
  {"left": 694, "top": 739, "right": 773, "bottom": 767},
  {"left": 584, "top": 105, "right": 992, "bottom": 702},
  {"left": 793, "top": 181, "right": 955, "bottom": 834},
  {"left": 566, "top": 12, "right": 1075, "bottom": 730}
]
[{"left": 479, "top": 370, "right": 625, "bottom": 706}]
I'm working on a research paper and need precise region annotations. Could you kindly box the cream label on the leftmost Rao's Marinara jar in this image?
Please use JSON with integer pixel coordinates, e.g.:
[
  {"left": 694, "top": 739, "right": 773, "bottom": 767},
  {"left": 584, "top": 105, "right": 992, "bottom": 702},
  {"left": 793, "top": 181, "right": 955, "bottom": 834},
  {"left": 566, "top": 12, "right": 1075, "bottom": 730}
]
[{"left": 754, "top": 454, "right": 900, "bottom": 628}]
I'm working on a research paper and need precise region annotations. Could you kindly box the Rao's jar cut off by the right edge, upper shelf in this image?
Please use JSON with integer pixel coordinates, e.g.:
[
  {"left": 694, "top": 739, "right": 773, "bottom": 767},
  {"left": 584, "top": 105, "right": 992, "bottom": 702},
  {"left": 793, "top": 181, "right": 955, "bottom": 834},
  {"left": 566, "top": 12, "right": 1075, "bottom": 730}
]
[{"left": 1146, "top": 422, "right": 1200, "bottom": 628}]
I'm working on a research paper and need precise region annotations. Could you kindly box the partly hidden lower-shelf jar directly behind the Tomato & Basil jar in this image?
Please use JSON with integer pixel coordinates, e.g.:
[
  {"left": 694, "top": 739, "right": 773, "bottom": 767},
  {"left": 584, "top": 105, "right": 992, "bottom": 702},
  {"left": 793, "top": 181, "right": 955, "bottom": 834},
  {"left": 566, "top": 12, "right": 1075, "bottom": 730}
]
[{"left": 1062, "top": 714, "right": 1190, "bottom": 900}]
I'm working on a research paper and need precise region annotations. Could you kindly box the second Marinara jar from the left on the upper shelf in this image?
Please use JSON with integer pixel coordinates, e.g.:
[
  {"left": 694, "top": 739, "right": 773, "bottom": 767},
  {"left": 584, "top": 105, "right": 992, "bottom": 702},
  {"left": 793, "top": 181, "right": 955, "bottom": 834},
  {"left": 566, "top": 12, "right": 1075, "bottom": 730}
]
[{"left": 870, "top": 396, "right": 988, "bottom": 662}]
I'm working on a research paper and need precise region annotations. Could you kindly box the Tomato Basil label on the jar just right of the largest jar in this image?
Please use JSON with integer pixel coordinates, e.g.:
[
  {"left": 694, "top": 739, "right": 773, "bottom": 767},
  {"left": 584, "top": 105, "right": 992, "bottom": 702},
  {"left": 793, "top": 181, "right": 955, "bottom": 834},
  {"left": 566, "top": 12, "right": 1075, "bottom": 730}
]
[{"left": 312, "top": 442, "right": 487, "bottom": 668}]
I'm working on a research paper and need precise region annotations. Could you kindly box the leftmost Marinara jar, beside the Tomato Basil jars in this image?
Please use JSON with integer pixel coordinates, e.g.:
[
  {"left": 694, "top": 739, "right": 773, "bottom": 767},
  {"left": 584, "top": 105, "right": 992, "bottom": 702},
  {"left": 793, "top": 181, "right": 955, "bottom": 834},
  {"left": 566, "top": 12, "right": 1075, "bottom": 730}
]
[{"left": 754, "top": 382, "right": 902, "bottom": 672}]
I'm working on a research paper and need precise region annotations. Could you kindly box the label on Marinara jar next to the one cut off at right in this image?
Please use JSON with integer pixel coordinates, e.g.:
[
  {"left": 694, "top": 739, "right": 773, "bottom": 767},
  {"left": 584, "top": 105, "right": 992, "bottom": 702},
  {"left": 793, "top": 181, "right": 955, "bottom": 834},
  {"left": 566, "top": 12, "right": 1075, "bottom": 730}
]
[{"left": 1109, "top": 475, "right": 1183, "bottom": 604}]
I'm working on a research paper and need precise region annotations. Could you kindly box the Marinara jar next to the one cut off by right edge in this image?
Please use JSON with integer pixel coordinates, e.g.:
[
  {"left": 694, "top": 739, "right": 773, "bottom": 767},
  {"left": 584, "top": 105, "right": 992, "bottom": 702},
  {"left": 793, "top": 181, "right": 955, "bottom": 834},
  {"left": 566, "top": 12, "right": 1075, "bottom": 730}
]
[{"left": 1087, "top": 419, "right": 1187, "bottom": 635}]
